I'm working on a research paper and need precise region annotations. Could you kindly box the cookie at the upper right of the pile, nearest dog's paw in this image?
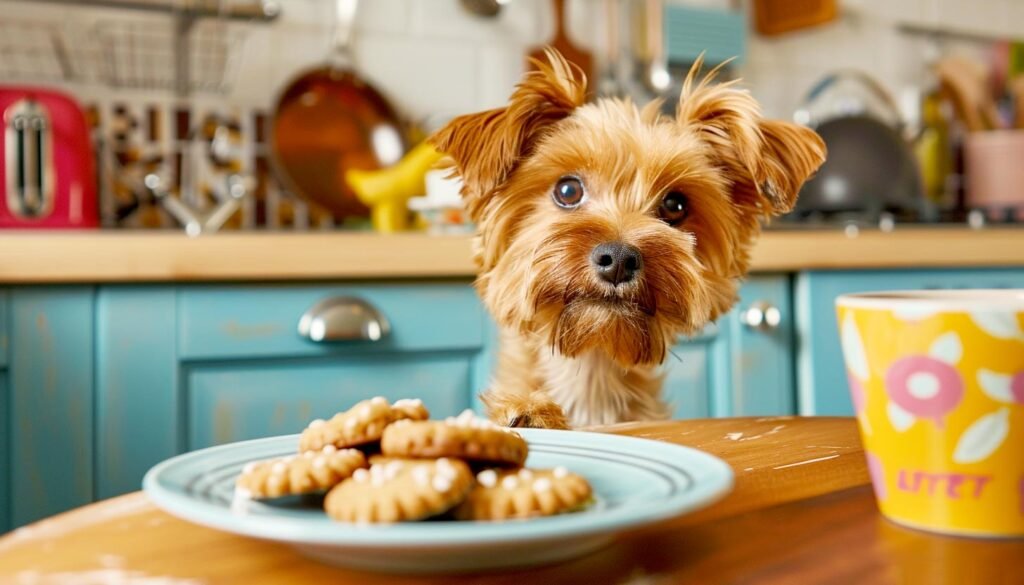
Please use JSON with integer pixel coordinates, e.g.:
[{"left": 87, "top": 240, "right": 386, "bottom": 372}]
[{"left": 381, "top": 410, "right": 528, "bottom": 466}]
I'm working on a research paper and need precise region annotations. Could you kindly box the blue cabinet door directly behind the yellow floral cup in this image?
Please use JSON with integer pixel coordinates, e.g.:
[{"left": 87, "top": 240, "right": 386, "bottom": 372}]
[{"left": 796, "top": 269, "right": 1024, "bottom": 416}]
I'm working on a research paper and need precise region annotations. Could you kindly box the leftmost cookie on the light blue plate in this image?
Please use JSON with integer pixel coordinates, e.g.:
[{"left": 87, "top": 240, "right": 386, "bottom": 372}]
[{"left": 234, "top": 445, "right": 367, "bottom": 499}]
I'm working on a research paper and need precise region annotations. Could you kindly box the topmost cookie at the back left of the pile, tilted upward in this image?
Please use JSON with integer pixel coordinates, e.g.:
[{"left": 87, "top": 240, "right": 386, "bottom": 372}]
[{"left": 299, "top": 396, "right": 430, "bottom": 451}]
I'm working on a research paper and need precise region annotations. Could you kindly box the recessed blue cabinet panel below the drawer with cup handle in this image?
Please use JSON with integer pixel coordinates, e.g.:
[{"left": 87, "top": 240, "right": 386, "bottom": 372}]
[{"left": 187, "top": 352, "right": 472, "bottom": 449}]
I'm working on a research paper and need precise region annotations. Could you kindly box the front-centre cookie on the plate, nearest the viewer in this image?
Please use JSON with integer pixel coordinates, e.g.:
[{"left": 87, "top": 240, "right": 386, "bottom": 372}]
[{"left": 324, "top": 458, "right": 473, "bottom": 524}]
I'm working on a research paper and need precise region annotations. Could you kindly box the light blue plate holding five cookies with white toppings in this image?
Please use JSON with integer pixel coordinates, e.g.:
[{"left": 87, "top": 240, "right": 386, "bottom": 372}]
[{"left": 143, "top": 396, "right": 733, "bottom": 573}]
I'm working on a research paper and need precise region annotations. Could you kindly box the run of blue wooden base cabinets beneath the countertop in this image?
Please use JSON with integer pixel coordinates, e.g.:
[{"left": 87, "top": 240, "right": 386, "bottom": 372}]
[{"left": 14, "top": 268, "right": 1024, "bottom": 531}]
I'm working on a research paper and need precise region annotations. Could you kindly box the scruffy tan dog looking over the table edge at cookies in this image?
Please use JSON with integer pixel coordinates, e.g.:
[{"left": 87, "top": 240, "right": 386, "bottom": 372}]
[{"left": 430, "top": 49, "right": 825, "bottom": 428}]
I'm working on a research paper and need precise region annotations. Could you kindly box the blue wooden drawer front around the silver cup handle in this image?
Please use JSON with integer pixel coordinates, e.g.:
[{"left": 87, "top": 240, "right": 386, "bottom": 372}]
[{"left": 178, "top": 283, "right": 483, "bottom": 360}]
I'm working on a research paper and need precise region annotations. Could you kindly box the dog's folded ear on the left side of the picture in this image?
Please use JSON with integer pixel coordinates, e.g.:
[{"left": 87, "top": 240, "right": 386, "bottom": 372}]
[{"left": 430, "top": 48, "right": 587, "bottom": 219}]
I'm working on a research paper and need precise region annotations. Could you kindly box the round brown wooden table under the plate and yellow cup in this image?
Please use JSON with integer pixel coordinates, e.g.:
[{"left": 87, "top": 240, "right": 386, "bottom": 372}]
[{"left": 0, "top": 417, "right": 1024, "bottom": 585}]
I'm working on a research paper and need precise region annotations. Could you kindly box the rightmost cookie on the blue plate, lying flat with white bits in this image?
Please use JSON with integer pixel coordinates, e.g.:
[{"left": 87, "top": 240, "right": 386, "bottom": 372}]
[{"left": 455, "top": 467, "right": 593, "bottom": 520}]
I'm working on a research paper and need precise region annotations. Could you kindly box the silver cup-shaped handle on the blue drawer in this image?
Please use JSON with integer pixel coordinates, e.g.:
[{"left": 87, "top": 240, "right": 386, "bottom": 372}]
[{"left": 299, "top": 296, "right": 391, "bottom": 343}]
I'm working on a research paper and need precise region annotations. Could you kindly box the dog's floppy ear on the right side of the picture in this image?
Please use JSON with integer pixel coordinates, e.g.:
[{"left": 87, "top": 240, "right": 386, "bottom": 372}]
[{"left": 676, "top": 59, "right": 825, "bottom": 215}]
